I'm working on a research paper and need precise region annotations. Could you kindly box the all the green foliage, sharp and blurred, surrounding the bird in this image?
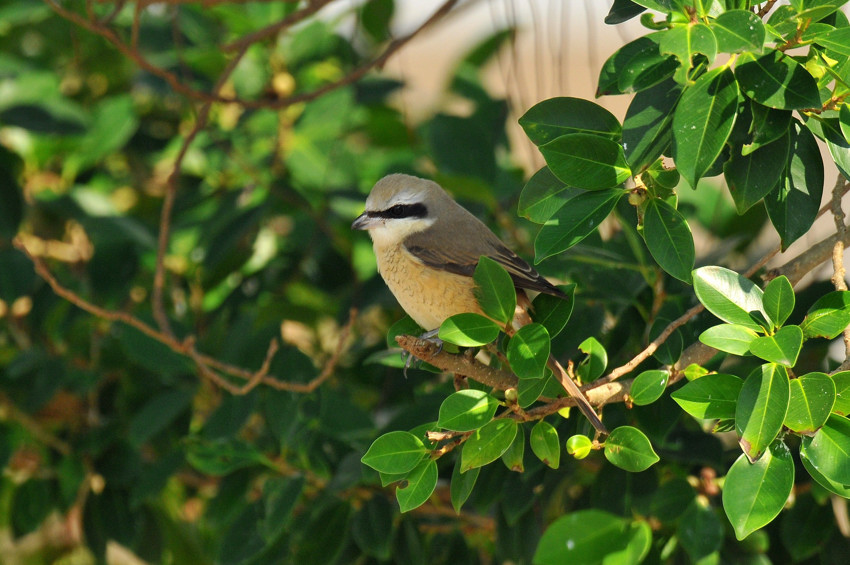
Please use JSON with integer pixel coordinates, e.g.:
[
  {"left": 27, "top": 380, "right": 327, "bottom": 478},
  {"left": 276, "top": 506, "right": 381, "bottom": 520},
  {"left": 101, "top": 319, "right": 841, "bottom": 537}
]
[{"left": 0, "top": 0, "right": 850, "bottom": 564}]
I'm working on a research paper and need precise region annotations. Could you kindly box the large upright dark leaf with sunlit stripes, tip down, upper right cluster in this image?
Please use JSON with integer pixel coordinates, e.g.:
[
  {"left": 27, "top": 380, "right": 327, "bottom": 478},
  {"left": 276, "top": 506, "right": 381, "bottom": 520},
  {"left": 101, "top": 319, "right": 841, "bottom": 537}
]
[{"left": 623, "top": 79, "right": 682, "bottom": 173}]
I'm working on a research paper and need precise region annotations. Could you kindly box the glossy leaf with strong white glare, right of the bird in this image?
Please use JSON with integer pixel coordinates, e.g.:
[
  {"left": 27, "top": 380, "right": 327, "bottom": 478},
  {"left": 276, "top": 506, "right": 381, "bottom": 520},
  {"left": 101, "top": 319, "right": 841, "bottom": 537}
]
[{"left": 694, "top": 266, "right": 767, "bottom": 332}]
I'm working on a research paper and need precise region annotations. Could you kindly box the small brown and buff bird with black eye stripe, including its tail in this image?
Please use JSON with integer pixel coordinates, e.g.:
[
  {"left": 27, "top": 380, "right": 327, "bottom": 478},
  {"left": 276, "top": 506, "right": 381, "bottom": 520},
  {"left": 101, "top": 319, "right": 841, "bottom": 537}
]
[{"left": 351, "top": 173, "right": 607, "bottom": 433}]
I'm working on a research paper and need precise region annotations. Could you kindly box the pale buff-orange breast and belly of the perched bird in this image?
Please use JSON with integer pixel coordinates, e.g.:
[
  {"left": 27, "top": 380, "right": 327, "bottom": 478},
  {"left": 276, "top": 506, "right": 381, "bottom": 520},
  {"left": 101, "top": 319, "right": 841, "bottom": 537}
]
[{"left": 374, "top": 240, "right": 482, "bottom": 330}]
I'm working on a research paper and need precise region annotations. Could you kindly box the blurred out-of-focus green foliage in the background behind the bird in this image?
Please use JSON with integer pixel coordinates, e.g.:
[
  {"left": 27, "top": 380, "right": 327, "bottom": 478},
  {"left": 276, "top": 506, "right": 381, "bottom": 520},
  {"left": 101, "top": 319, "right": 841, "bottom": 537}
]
[{"left": 0, "top": 0, "right": 850, "bottom": 564}]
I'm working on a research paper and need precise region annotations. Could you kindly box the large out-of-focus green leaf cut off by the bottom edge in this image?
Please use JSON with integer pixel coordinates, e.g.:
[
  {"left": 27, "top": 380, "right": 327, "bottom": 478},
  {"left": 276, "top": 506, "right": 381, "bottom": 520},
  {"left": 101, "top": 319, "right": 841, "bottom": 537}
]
[{"left": 532, "top": 510, "right": 627, "bottom": 565}]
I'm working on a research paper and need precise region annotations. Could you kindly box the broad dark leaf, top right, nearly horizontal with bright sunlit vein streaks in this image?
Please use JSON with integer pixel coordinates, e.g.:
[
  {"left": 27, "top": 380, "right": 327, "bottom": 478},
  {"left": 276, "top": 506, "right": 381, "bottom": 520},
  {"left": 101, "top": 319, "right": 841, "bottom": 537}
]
[{"left": 735, "top": 49, "right": 820, "bottom": 110}]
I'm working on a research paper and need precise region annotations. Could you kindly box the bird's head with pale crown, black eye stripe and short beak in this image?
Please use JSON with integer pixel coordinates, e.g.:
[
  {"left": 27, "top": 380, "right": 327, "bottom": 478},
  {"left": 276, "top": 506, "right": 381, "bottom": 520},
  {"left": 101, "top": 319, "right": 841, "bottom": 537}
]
[{"left": 351, "top": 174, "right": 448, "bottom": 245}]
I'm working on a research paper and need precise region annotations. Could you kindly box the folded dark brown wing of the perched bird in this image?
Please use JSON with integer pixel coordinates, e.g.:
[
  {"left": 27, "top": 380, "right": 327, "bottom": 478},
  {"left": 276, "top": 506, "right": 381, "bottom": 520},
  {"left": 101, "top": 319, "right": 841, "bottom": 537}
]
[{"left": 404, "top": 214, "right": 566, "bottom": 298}]
